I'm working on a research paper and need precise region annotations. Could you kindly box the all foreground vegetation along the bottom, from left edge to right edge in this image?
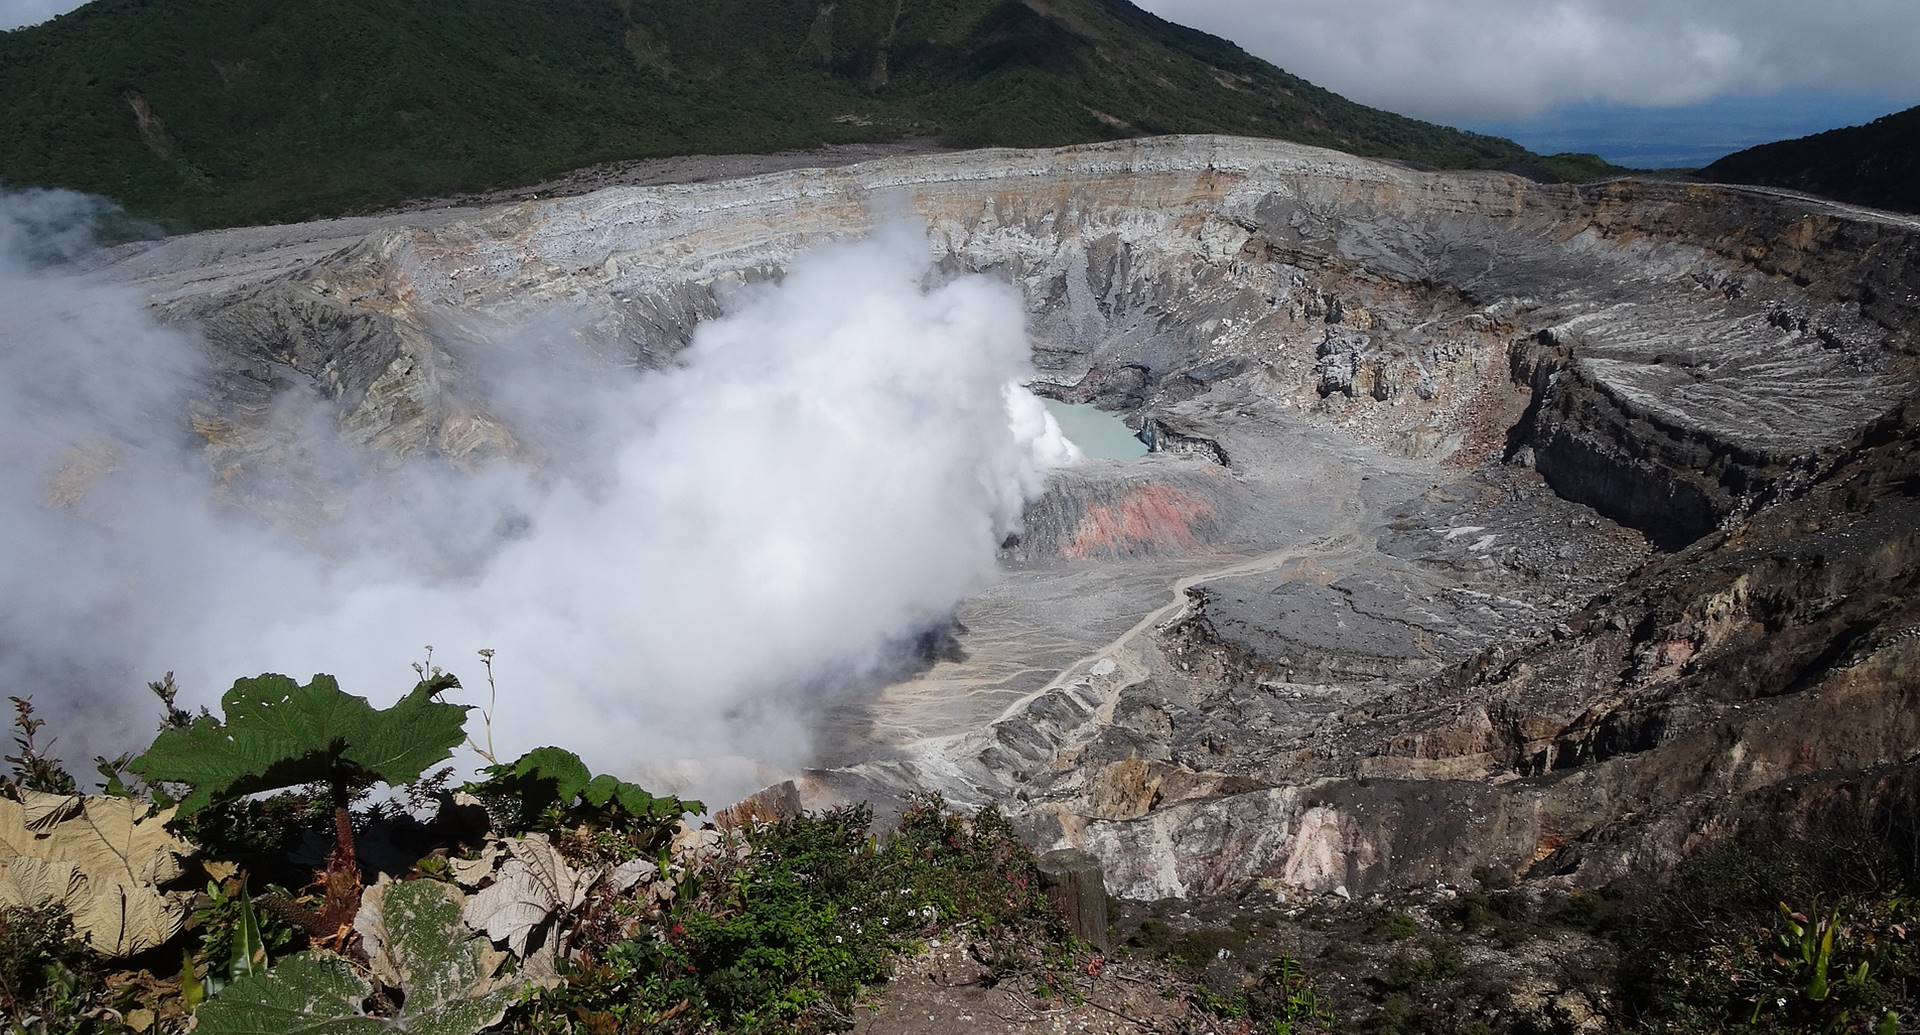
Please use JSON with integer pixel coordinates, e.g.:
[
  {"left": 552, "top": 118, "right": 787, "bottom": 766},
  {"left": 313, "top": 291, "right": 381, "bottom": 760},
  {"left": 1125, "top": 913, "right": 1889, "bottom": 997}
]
[{"left": 0, "top": 662, "right": 1920, "bottom": 1035}]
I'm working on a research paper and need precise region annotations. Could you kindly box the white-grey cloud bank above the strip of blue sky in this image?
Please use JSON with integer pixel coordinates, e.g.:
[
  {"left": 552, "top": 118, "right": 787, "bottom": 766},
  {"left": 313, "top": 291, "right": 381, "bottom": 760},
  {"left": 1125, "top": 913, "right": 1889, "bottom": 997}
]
[{"left": 1139, "top": 0, "right": 1920, "bottom": 121}]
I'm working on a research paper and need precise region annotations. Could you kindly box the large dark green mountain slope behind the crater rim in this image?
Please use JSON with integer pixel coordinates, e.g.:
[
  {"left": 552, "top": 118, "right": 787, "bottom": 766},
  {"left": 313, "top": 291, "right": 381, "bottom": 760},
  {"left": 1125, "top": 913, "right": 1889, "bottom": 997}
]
[{"left": 0, "top": 0, "right": 1594, "bottom": 225}]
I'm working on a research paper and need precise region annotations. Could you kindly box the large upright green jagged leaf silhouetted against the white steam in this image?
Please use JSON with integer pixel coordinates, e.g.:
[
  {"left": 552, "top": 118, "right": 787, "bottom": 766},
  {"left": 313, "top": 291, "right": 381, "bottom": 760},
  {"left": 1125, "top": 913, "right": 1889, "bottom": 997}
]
[{"left": 129, "top": 674, "right": 467, "bottom": 818}]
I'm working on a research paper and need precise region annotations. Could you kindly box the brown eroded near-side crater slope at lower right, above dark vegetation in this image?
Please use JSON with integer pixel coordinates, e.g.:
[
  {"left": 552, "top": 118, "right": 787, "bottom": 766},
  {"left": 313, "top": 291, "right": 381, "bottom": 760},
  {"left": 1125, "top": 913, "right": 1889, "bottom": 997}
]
[{"left": 1006, "top": 401, "right": 1920, "bottom": 897}]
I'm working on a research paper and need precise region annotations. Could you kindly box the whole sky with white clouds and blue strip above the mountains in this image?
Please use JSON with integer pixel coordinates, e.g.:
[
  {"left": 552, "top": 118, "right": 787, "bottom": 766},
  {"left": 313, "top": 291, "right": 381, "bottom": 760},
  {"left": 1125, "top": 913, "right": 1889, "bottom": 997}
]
[{"left": 0, "top": 0, "right": 1920, "bottom": 167}]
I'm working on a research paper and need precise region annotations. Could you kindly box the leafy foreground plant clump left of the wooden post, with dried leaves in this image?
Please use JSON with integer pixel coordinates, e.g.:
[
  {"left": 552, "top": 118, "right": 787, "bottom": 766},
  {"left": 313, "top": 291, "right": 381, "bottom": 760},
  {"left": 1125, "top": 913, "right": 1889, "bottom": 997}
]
[{"left": 0, "top": 662, "right": 1077, "bottom": 1035}]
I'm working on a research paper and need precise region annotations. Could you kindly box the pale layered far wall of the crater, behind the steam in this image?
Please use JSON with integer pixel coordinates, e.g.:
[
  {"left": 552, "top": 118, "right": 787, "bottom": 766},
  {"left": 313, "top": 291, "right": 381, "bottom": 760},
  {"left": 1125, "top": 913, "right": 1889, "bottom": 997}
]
[{"left": 111, "top": 138, "right": 1920, "bottom": 545}]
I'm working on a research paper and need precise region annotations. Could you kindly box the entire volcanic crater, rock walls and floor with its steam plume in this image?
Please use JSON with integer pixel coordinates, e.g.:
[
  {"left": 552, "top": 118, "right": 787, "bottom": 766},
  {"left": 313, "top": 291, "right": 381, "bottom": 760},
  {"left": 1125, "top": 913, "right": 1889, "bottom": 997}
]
[{"left": 18, "top": 138, "right": 1920, "bottom": 899}]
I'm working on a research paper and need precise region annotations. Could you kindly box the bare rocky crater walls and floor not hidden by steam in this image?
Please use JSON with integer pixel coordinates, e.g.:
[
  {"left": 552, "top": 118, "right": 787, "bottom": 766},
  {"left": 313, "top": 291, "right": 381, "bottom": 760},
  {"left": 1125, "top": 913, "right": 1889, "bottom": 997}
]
[{"left": 97, "top": 138, "right": 1920, "bottom": 914}]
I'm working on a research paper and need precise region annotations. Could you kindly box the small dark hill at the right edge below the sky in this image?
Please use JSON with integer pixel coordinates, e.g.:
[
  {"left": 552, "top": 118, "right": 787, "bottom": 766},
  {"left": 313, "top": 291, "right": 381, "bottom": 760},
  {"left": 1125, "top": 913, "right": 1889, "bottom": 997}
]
[{"left": 1699, "top": 108, "right": 1920, "bottom": 211}]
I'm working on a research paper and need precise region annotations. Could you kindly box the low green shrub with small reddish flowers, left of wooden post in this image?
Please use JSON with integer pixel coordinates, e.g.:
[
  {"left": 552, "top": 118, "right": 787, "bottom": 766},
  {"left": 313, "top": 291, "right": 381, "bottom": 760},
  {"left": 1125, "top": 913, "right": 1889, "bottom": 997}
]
[{"left": 515, "top": 799, "right": 1058, "bottom": 1031}]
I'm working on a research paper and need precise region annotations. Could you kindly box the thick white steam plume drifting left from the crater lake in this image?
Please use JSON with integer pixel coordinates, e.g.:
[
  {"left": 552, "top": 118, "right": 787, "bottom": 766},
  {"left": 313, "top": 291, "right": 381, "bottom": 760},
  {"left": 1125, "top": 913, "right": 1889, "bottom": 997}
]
[{"left": 0, "top": 192, "right": 1075, "bottom": 793}]
